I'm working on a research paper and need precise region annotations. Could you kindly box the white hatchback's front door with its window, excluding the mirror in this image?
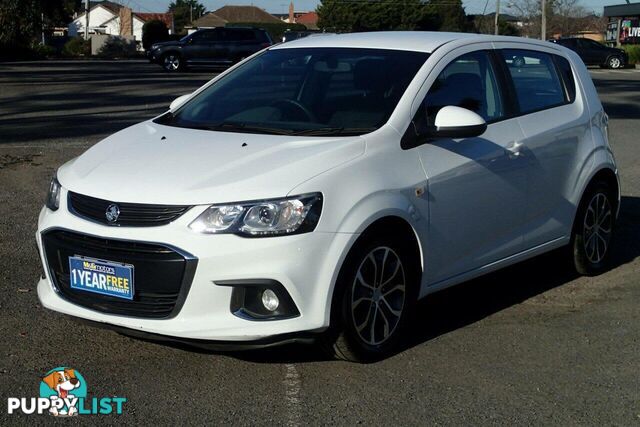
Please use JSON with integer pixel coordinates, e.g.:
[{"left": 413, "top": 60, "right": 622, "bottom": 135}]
[{"left": 416, "top": 48, "right": 527, "bottom": 285}]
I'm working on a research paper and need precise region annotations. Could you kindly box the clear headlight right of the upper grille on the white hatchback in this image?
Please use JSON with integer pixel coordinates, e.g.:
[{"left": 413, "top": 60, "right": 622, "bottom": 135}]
[{"left": 189, "top": 193, "right": 322, "bottom": 237}]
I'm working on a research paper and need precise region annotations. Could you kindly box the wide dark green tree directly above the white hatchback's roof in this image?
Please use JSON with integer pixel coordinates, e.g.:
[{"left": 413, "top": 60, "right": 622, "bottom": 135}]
[{"left": 317, "top": 0, "right": 467, "bottom": 32}]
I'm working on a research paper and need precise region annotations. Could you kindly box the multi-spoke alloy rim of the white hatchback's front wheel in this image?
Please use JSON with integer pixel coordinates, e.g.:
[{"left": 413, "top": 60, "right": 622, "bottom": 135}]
[{"left": 351, "top": 246, "right": 406, "bottom": 346}]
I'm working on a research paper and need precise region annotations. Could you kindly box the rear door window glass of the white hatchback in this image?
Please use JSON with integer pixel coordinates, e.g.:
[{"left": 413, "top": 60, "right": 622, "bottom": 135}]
[{"left": 502, "top": 49, "right": 566, "bottom": 113}]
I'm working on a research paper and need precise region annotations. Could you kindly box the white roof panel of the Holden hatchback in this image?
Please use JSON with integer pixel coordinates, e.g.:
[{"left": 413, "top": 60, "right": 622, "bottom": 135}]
[{"left": 272, "top": 31, "right": 548, "bottom": 53}]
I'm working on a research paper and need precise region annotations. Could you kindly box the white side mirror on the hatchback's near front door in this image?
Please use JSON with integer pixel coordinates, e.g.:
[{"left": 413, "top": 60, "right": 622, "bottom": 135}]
[{"left": 431, "top": 105, "right": 487, "bottom": 138}]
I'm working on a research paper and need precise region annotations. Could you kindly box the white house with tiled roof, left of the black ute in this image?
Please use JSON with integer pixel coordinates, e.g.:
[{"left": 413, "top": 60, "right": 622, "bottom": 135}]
[{"left": 68, "top": 1, "right": 174, "bottom": 50}]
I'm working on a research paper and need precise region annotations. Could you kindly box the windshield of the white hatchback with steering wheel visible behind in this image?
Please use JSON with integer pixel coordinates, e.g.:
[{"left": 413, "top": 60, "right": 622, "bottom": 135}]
[{"left": 157, "top": 48, "right": 428, "bottom": 136}]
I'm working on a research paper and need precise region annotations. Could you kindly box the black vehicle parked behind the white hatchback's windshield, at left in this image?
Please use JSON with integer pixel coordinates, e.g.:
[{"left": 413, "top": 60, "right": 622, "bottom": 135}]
[{"left": 147, "top": 28, "right": 272, "bottom": 71}]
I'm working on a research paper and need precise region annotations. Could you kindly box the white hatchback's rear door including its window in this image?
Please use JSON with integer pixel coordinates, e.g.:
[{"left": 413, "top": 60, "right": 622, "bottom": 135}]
[{"left": 500, "top": 44, "right": 593, "bottom": 249}]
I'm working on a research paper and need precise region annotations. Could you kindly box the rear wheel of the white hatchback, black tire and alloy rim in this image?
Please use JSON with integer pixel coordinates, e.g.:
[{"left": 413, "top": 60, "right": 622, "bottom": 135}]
[{"left": 569, "top": 181, "right": 617, "bottom": 276}]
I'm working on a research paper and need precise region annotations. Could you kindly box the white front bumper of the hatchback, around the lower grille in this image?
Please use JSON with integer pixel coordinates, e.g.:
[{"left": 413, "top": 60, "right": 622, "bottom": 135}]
[{"left": 36, "top": 190, "right": 357, "bottom": 342}]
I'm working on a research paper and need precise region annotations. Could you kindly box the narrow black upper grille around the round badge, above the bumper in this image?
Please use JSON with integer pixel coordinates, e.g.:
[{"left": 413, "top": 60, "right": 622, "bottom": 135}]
[{"left": 68, "top": 191, "right": 191, "bottom": 227}]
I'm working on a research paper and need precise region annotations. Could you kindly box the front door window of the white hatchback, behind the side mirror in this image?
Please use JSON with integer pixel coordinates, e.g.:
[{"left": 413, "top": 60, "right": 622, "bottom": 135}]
[{"left": 424, "top": 51, "right": 505, "bottom": 126}]
